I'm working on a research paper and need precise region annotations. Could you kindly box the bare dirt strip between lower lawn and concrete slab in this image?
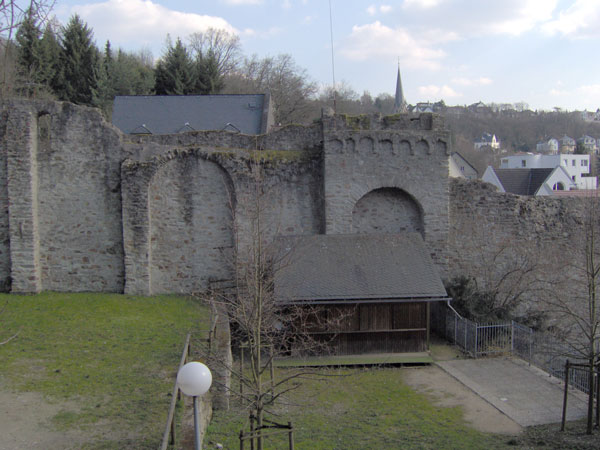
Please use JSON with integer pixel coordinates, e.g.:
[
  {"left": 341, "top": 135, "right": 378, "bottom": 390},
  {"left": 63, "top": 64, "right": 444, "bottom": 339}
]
[{"left": 404, "top": 366, "right": 522, "bottom": 435}]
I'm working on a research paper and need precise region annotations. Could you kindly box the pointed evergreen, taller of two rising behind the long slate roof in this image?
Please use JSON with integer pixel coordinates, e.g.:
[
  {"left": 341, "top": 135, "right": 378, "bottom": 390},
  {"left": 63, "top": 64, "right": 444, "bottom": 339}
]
[{"left": 154, "top": 38, "right": 196, "bottom": 95}]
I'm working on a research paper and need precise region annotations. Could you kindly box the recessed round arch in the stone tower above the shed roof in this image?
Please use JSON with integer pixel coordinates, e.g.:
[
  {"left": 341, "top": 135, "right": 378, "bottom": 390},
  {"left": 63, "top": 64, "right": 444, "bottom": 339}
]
[{"left": 352, "top": 187, "right": 425, "bottom": 235}]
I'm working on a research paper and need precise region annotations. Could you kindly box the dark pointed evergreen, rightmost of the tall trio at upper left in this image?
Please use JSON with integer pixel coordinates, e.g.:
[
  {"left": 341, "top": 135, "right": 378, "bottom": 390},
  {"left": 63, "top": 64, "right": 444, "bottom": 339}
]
[{"left": 58, "top": 15, "right": 99, "bottom": 105}]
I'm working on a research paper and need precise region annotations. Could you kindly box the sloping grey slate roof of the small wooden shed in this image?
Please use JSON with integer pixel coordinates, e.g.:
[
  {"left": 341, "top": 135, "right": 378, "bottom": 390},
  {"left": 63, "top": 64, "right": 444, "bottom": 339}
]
[{"left": 275, "top": 233, "right": 447, "bottom": 302}]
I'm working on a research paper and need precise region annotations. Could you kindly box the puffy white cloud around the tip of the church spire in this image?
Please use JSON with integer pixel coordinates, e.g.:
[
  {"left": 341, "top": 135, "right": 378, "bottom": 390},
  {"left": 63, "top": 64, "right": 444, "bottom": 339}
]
[{"left": 339, "top": 21, "right": 454, "bottom": 69}]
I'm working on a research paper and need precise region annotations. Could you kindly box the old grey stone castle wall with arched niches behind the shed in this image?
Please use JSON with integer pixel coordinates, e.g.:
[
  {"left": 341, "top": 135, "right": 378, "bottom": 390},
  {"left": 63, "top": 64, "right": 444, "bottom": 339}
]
[{"left": 0, "top": 101, "right": 581, "bottom": 294}]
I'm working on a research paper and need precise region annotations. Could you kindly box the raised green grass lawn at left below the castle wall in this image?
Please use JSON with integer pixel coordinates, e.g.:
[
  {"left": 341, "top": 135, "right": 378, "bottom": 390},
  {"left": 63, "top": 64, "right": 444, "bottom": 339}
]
[{"left": 0, "top": 293, "right": 209, "bottom": 448}]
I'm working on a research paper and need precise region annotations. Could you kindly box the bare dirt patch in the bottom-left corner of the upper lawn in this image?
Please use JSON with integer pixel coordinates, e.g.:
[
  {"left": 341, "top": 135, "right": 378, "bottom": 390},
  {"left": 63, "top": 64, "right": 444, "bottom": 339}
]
[{"left": 0, "top": 391, "right": 86, "bottom": 450}]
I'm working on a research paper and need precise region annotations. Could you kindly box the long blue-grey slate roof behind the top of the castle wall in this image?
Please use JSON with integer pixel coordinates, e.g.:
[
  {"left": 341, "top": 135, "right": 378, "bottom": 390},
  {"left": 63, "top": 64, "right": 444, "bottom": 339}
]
[{"left": 112, "top": 94, "right": 272, "bottom": 135}]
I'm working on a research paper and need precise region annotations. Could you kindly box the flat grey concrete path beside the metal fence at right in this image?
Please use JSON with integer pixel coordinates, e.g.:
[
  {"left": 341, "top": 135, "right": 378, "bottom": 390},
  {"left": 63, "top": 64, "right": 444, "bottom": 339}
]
[{"left": 437, "top": 358, "right": 587, "bottom": 426}]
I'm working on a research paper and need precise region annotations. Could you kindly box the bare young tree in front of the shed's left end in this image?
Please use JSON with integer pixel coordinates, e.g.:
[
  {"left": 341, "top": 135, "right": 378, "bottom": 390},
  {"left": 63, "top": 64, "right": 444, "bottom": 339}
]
[{"left": 205, "top": 155, "right": 341, "bottom": 449}]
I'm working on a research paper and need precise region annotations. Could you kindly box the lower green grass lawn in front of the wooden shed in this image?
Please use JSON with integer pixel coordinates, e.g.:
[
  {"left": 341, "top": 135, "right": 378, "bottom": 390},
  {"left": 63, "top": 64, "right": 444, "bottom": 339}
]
[{"left": 204, "top": 368, "right": 514, "bottom": 450}]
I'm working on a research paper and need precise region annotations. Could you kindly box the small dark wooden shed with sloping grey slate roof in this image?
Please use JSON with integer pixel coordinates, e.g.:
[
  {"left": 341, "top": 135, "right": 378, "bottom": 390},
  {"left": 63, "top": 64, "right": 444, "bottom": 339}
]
[{"left": 275, "top": 233, "right": 449, "bottom": 355}]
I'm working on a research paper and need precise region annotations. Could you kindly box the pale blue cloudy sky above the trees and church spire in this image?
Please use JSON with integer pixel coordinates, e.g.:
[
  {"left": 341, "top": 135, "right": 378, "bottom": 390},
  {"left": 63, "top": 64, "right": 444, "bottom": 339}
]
[{"left": 39, "top": 0, "right": 600, "bottom": 111}]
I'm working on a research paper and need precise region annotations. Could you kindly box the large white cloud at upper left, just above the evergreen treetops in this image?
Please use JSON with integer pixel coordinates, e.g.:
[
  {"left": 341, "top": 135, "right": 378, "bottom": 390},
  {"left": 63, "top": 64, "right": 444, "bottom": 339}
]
[{"left": 70, "top": 0, "right": 237, "bottom": 49}]
